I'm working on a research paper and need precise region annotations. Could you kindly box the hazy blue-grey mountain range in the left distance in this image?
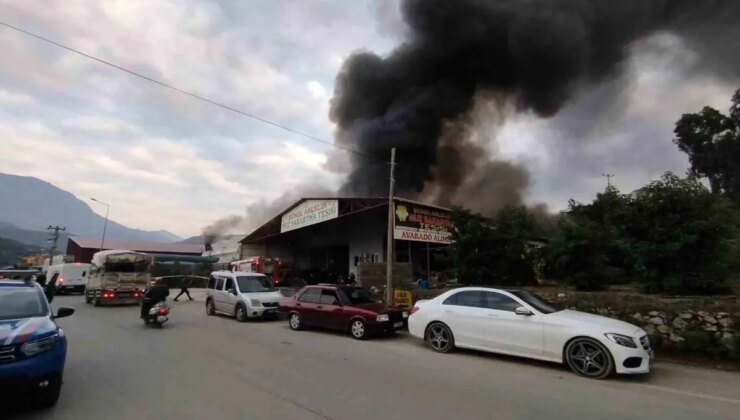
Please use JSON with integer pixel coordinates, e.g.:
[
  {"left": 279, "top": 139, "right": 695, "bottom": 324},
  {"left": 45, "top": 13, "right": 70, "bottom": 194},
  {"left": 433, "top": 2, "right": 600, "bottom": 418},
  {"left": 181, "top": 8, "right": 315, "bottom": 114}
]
[{"left": 0, "top": 173, "right": 182, "bottom": 248}]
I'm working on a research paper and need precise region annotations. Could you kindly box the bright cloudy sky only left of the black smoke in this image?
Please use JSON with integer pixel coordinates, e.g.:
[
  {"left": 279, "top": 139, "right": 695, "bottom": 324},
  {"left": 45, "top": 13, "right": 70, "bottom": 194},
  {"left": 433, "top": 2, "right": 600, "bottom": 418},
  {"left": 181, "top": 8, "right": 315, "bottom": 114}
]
[{"left": 0, "top": 0, "right": 389, "bottom": 236}]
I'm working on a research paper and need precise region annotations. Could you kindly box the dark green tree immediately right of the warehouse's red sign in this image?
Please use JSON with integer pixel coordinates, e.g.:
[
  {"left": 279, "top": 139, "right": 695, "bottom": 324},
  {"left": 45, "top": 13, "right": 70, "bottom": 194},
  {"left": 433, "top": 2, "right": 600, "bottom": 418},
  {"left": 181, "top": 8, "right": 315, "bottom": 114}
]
[{"left": 450, "top": 206, "right": 536, "bottom": 286}]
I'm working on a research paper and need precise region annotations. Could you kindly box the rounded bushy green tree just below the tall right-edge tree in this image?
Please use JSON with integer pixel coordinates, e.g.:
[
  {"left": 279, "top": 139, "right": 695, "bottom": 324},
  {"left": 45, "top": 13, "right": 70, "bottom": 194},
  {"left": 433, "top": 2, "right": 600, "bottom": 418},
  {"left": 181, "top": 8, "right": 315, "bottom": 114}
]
[{"left": 626, "top": 172, "right": 740, "bottom": 294}]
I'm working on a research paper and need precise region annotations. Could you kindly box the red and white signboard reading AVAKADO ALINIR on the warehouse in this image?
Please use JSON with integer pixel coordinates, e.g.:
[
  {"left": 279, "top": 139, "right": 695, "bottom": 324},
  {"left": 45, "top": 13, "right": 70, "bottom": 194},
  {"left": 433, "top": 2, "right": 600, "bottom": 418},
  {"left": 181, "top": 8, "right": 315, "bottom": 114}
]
[{"left": 393, "top": 202, "right": 453, "bottom": 244}]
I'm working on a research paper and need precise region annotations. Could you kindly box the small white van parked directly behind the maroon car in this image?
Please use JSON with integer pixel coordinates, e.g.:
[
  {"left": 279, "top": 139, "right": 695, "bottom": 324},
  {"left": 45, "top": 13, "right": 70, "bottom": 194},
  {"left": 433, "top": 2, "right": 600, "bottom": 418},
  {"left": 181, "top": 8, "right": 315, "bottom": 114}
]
[{"left": 206, "top": 271, "right": 284, "bottom": 322}]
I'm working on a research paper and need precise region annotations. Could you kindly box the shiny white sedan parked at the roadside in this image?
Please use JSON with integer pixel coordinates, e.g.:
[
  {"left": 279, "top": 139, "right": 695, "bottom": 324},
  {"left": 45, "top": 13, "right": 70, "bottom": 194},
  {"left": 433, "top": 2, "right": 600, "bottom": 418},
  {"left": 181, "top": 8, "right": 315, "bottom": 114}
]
[{"left": 409, "top": 287, "right": 653, "bottom": 379}]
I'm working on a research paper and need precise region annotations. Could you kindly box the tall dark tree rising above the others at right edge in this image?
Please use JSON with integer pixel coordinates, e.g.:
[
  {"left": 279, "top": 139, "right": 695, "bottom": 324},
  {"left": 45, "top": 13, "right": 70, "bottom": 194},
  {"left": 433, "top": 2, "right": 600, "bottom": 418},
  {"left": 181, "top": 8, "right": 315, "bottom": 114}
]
[{"left": 673, "top": 89, "right": 740, "bottom": 199}]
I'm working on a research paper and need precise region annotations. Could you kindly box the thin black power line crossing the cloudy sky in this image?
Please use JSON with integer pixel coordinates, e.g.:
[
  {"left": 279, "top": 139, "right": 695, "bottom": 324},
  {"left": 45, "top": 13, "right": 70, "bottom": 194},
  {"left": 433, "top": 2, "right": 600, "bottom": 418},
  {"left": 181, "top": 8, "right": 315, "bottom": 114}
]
[{"left": 0, "top": 20, "right": 378, "bottom": 160}]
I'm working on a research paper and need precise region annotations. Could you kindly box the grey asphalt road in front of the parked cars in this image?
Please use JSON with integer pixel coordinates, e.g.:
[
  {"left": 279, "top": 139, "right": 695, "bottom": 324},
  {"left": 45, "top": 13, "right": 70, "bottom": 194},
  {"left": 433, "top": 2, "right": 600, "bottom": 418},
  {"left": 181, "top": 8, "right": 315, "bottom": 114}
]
[{"left": 7, "top": 295, "right": 740, "bottom": 420}]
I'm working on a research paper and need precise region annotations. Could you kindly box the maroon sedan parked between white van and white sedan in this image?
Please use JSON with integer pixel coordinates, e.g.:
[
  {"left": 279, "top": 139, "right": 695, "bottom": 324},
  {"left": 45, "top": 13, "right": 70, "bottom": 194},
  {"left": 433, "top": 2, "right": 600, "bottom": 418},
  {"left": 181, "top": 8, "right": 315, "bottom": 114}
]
[{"left": 279, "top": 285, "right": 409, "bottom": 340}]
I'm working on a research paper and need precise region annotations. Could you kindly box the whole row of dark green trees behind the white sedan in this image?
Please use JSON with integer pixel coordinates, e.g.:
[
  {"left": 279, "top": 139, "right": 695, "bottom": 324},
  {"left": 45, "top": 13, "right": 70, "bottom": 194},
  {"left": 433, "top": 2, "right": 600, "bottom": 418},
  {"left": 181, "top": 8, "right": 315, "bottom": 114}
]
[{"left": 450, "top": 90, "right": 740, "bottom": 294}]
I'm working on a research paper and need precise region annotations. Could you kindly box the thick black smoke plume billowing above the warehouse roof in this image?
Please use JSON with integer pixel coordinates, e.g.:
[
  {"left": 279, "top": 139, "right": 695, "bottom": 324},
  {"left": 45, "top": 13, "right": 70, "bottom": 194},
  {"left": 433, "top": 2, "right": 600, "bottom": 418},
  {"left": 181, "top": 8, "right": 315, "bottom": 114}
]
[{"left": 331, "top": 0, "right": 740, "bottom": 212}]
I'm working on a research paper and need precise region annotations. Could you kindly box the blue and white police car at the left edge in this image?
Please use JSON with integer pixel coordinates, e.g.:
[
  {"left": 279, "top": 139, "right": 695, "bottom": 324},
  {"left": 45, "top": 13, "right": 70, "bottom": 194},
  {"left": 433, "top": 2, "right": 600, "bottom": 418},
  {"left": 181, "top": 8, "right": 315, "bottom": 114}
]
[{"left": 0, "top": 280, "right": 74, "bottom": 407}]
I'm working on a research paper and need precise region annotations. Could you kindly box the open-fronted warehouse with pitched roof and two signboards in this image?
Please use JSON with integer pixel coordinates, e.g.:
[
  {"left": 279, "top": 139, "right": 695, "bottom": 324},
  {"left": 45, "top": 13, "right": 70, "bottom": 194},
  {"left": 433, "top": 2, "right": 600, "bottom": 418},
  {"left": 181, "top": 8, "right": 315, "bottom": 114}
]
[{"left": 240, "top": 198, "right": 452, "bottom": 283}]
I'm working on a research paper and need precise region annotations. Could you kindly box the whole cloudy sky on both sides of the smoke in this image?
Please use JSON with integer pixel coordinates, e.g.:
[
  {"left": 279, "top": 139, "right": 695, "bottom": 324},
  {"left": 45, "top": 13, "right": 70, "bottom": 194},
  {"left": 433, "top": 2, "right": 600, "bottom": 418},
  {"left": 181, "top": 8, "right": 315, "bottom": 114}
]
[{"left": 0, "top": 0, "right": 737, "bottom": 236}]
